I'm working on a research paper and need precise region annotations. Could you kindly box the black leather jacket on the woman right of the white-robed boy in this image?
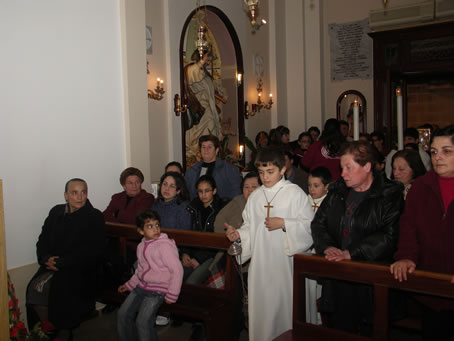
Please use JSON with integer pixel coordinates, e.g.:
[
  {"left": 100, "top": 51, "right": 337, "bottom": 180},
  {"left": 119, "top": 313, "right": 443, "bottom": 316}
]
[{"left": 311, "top": 173, "right": 404, "bottom": 261}]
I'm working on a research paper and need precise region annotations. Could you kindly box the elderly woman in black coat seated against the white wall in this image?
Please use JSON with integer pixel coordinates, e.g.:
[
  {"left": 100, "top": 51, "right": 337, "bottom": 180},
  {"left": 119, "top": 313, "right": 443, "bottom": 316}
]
[{"left": 27, "top": 178, "right": 104, "bottom": 340}]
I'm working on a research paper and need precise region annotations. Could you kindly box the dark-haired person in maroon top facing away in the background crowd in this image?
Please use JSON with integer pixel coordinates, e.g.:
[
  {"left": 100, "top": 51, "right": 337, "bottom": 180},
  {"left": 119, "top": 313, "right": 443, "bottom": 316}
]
[{"left": 300, "top": 118, "right": 345, "bottom": 181}]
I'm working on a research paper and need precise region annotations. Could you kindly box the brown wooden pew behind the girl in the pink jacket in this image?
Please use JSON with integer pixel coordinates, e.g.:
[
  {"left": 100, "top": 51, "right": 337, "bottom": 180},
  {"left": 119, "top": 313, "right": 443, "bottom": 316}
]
[{"left": 103, "top": 223, "right": 240, "bottom": 341}]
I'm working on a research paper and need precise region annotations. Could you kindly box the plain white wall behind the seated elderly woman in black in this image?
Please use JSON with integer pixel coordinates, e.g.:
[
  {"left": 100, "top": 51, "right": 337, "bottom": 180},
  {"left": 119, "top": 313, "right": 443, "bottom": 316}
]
[{"left": 0, "top": 0, "right": 126, "bottom": 268}]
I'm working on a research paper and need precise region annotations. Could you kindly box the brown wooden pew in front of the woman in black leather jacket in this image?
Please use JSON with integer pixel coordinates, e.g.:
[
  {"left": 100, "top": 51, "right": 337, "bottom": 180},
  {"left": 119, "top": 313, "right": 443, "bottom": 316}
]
[{"left": 275, "top": 254, "right": 454, "bottom": 341}]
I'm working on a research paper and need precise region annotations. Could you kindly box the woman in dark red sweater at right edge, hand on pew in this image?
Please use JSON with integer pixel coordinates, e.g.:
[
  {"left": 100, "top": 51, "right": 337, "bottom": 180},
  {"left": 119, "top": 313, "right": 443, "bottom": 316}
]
[{"left": 390, "top": 125, "right": 454, "bottom": 340}]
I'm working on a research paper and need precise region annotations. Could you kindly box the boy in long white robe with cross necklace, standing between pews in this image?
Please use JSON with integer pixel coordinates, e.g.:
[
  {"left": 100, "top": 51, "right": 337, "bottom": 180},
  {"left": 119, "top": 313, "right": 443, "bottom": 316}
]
[{"left": 225, "top": 148, "right": 314, "bottom": 341}]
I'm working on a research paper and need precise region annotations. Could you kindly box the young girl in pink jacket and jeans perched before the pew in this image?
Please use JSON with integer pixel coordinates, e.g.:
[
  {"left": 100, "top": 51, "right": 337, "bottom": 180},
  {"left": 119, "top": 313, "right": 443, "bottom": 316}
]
[{"left": 117, "top": 209, "right": 183, "bottom": 341}]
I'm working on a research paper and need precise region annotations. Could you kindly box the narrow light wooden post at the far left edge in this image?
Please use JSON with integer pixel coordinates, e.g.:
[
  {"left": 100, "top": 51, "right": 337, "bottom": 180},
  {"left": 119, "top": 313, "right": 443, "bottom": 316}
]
[{"left": 0, "top": 179, "right": 9, "bottom": 340}]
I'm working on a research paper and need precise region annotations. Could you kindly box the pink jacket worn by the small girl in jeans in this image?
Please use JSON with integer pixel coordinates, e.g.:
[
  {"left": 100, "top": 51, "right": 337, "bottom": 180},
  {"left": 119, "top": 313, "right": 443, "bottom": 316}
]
[{"left": 125, "top": 233, "right": 183, "bottom": 302}]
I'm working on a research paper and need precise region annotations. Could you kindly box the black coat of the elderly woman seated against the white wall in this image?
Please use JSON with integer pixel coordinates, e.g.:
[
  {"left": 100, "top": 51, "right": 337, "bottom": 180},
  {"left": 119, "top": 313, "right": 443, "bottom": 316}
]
[{"left": 27, "top": 200, "right": 104, "bottom": 329}]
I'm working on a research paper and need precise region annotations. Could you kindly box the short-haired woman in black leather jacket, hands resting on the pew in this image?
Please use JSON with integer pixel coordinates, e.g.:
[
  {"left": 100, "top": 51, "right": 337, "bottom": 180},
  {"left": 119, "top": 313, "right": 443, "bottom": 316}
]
[{"left": 311, "top": 141, "right": 404, "bottom": 335}]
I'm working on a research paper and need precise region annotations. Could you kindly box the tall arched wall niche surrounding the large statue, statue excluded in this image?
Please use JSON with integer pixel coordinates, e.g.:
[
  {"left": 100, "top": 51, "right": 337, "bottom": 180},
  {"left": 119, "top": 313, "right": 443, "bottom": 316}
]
[{"left": 179, "top": 6, "right": 245, "bottom": 168}]
